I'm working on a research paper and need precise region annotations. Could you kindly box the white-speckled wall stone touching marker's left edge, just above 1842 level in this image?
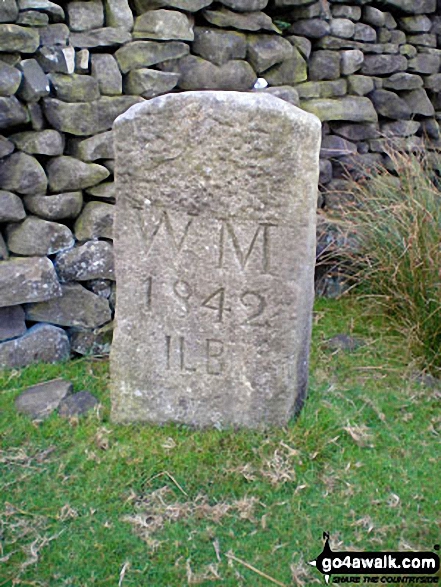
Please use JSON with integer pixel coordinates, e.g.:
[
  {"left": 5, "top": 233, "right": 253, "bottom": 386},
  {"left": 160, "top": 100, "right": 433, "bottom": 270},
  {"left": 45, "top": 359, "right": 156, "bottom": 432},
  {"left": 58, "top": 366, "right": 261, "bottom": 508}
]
[{"left": 55, "top": 241, "right": 115, "bottom": 281}]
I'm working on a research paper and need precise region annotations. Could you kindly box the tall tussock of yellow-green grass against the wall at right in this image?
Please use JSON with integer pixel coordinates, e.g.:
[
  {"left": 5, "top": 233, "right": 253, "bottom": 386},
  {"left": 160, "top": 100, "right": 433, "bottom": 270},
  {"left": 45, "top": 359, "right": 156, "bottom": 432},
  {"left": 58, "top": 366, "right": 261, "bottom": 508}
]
[{"left": 334, "top": 150, "right": 441, "bottom": 373}]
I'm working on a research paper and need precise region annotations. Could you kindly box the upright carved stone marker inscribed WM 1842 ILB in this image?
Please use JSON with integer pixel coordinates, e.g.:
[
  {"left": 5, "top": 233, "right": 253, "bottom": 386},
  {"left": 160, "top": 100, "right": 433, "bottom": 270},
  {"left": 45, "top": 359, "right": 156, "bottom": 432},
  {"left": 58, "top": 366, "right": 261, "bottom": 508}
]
[{"left": 111, "top": 92, "right": 320, "bottom": 427}]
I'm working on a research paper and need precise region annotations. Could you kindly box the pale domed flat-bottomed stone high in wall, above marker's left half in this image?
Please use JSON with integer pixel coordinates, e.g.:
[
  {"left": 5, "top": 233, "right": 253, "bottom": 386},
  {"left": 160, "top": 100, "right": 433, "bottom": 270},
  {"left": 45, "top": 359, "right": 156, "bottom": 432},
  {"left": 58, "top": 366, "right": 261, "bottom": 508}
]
[{"left": 133, "top": 9, "right": 194, "bottom": 41}]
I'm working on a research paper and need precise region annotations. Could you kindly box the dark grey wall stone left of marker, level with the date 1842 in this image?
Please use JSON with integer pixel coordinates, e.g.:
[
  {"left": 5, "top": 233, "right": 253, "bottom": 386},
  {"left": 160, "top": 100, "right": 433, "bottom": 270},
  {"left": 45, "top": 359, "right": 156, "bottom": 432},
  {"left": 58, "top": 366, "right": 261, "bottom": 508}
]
[{"left": 25, "top": 283, "right": 112, "bottom": 328}]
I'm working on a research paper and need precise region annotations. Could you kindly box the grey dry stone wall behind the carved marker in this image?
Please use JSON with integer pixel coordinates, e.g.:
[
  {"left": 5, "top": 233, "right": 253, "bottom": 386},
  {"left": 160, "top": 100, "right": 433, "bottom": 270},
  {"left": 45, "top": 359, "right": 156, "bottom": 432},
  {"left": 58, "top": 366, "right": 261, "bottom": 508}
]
[{"left": 0, "top": 0, "right": 441, "bottom": 367}]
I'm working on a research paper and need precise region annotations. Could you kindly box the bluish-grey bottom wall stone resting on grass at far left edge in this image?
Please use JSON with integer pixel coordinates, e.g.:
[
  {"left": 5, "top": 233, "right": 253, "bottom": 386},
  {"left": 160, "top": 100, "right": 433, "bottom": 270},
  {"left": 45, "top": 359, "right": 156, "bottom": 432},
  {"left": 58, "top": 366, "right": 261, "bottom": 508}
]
[{"left": 0, "top": 324, "right": 70, "bottom": 369}]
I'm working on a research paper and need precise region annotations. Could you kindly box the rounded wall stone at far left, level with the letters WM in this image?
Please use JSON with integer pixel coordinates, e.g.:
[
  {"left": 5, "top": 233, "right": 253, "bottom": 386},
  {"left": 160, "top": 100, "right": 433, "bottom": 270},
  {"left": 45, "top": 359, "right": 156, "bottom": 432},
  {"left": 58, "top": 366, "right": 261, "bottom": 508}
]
[{"left": 6, "top": 216, "right": 75, "bottom": 256}]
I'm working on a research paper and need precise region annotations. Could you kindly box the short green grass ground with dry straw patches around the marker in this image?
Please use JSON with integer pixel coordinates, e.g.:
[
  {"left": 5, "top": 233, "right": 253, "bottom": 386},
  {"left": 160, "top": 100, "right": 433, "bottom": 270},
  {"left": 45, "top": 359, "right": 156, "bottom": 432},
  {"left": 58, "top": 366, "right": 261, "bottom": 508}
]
[{"left": 0, "top": 297, "right": 441, "bottom": 587}]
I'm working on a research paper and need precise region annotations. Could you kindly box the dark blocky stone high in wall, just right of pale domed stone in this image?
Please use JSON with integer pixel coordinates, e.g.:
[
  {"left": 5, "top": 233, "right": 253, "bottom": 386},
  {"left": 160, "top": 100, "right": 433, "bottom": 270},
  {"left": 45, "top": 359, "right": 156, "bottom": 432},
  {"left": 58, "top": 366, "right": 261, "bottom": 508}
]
[{"left": 192, "top": 27, "right": 247, "bottom": 65}]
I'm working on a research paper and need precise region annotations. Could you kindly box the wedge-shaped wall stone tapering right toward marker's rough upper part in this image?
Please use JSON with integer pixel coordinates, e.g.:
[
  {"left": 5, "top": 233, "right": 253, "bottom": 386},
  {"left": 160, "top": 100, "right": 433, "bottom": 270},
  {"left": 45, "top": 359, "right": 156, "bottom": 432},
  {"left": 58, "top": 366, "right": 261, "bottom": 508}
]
[{"left": 46, "top": 157, "right": 109, "bottom": 192}]
